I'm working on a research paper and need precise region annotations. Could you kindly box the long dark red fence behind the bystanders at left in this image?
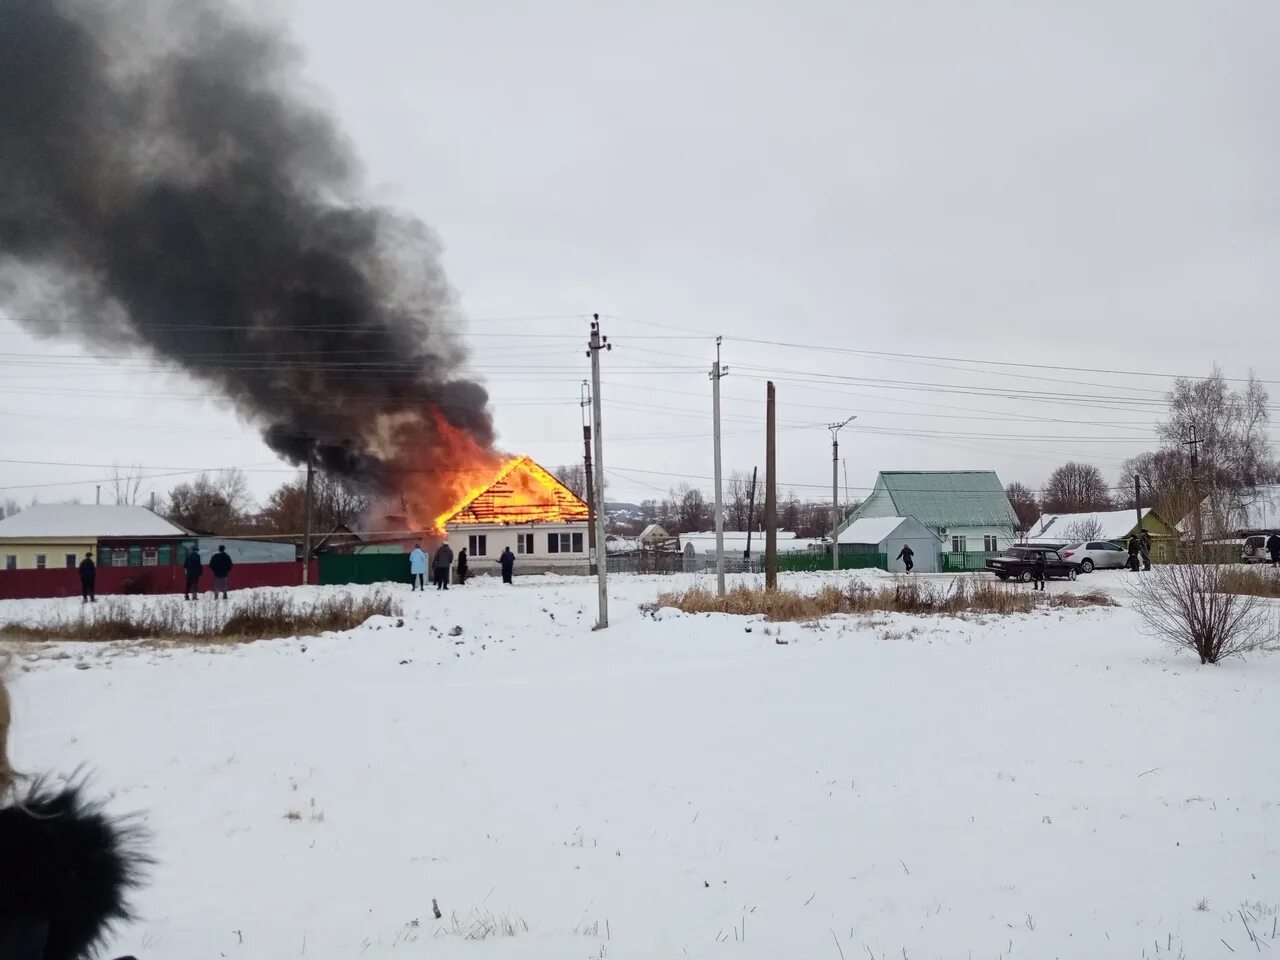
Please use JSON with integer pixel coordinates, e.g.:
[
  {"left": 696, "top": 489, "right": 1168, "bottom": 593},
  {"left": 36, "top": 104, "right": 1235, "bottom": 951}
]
[{"left": 0, "top": 561, "right": 320, "bottom": 600}]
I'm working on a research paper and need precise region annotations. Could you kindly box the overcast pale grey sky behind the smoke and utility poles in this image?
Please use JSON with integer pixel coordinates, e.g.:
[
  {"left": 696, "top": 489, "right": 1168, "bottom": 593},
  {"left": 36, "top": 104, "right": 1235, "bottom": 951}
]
[{"left": 0, "top": 0, "right": 1280, "bottom": 512}]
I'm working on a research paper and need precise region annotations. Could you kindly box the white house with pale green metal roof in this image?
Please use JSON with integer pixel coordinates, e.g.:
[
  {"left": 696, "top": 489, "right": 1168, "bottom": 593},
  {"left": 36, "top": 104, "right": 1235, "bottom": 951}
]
[{"left": 841, "top": 470, "right": 1018, "bottom": 553}]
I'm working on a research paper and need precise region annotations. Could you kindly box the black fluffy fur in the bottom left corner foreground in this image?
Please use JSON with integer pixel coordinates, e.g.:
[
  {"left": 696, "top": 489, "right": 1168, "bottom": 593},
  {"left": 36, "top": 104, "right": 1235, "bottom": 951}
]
[{"left": 0, "top": 785, "right": 151, "bottom": 960}]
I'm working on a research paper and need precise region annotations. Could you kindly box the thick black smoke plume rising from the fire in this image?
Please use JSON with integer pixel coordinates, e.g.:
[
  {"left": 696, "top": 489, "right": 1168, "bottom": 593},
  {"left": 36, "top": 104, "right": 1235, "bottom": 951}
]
[{"left": 0, "top": 0, "right": 493, "bottom": 490}]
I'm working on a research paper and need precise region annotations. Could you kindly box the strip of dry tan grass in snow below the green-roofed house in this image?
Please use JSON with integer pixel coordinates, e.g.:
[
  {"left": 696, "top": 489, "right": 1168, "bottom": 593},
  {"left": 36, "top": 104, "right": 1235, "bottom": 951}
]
[{"left": 646, "top": 577, "right": 1115, "bottom": 621}]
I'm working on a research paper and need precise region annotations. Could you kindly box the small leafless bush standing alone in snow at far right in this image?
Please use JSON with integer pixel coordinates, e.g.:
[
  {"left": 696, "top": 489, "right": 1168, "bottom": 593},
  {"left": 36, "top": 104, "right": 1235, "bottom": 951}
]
[{"left": 1130, "top": 563, "right": 1280, "bottom": 663}]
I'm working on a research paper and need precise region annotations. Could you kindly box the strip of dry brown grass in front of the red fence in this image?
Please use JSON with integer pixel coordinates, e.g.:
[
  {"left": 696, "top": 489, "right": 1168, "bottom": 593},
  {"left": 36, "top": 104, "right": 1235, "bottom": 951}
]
[{"left": 0, "top": 590, "right": 401, "bottom": 643}]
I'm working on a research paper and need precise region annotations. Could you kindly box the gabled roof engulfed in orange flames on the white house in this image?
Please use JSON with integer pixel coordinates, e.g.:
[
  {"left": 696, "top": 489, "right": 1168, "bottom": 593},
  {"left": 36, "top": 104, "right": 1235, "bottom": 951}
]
[{"left": 436, "top": 457, "right": 588, "bottom": 530}]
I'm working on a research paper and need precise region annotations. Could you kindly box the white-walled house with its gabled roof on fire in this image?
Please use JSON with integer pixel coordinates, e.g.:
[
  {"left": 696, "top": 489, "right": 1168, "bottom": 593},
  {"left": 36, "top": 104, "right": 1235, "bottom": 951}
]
[{"left": 438, "top": 457, "right": 590, "bottom": 573}]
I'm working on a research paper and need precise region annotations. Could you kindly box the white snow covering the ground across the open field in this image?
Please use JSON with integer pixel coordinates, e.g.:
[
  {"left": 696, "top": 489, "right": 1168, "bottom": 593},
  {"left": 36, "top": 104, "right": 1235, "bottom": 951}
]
[{"left": 0, "top": 572, "right": 1280, "bottom": 960}]
